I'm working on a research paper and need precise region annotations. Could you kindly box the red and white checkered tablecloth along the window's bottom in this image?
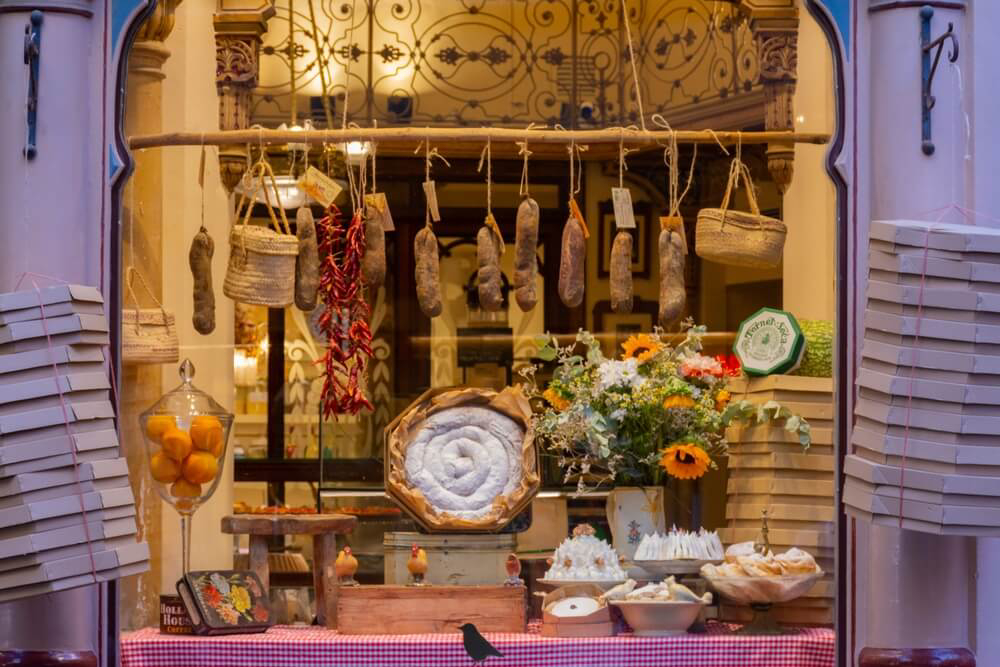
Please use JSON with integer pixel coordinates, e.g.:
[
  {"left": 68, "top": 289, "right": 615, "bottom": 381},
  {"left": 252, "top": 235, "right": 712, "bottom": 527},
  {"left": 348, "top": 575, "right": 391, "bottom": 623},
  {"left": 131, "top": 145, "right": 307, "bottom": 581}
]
[{"left": 121, "top": 623, "right": 834, "bottom": 667}]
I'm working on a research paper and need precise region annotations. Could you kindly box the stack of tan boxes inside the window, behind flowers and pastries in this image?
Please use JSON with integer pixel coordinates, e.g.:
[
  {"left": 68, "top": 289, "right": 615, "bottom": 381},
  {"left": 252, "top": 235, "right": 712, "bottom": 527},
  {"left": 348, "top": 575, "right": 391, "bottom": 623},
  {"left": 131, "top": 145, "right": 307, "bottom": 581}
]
[{"left": 719, "top": 375, "right": 836, "bottom": 624}]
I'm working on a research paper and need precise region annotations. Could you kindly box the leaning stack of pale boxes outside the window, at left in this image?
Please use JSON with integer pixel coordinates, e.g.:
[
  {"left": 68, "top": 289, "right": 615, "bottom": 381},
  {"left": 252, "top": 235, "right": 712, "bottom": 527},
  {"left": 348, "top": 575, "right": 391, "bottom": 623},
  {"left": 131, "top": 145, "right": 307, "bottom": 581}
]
[{"left": 0, "top": 285, "right": 149, "bottom": 601}]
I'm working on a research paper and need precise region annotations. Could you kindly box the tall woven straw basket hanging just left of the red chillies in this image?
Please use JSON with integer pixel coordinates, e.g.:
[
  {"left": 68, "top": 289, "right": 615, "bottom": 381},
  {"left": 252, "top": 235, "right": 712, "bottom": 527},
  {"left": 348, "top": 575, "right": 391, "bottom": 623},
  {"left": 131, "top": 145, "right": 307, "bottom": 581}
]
[{"left": 222, "top": 161, "right": 299, "bottom": 308}]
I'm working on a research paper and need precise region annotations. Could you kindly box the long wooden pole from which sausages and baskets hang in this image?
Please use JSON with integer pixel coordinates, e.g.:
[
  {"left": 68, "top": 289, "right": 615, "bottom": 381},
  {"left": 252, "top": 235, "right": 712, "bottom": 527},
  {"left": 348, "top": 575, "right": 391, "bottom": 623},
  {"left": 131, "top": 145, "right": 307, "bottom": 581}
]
[{"left": 129, "top": 127, "right": 830, "bottom": 150}]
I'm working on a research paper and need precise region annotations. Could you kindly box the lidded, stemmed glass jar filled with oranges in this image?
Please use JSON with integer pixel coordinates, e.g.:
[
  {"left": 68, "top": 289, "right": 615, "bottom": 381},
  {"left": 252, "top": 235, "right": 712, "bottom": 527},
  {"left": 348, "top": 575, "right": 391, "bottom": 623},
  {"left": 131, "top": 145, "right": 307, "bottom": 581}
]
[{"left": 139, "top": 359, "right": 233, "bottom": 573}]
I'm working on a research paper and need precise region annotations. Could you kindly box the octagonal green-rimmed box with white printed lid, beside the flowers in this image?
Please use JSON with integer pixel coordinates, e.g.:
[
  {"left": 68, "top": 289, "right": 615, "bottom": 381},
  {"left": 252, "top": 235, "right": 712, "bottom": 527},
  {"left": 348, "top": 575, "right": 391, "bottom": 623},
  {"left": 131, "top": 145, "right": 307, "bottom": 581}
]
[{"left": 733, "top": 308, "right": 806, "bottom": 375}]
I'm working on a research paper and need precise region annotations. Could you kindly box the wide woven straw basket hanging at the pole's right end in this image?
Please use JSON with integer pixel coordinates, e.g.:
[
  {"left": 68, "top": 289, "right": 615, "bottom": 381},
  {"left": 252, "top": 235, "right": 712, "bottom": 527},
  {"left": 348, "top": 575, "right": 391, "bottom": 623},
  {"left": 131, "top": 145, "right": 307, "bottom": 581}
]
[{"left": 695, "top": 158, "right": 787, "bottom": 269}]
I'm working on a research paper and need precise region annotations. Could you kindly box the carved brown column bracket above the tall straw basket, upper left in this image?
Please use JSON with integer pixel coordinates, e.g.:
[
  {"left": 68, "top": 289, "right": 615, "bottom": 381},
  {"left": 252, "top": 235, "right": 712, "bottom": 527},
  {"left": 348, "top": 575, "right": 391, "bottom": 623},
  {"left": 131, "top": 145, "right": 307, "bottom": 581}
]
[{"left": 214, "top": 0, "right": 274, "bottom": 193}]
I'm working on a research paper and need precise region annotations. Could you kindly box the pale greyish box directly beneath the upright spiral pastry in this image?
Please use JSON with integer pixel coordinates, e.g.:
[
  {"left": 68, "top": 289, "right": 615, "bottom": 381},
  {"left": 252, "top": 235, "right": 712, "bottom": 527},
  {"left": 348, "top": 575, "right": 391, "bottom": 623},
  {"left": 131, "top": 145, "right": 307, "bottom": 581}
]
[{"left": 383, "top": 532, "right": 516, "bottom": 586}]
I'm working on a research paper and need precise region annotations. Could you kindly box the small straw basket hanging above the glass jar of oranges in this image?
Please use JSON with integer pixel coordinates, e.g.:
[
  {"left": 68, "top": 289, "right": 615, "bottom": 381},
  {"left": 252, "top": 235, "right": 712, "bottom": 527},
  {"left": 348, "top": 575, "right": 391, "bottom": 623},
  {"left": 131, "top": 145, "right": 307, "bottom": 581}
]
[{"left": 122, "top": 267, "right": 180, "bottom": 364}]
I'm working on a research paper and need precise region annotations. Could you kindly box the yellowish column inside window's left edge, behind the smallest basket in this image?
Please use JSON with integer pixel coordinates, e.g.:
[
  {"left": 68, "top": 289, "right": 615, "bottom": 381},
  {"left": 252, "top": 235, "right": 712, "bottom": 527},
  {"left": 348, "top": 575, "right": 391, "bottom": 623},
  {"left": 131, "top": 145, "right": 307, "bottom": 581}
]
[{"left": 119, "top": 0, "right": 181, "bottom": 630}]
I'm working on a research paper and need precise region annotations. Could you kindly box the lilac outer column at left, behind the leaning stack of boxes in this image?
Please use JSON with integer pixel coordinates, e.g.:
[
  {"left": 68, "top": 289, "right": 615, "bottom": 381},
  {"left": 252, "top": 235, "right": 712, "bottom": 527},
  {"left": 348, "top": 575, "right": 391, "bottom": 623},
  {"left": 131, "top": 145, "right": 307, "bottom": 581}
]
[{"left": 0, "top": 0, "right": 104, "bottom": 652}]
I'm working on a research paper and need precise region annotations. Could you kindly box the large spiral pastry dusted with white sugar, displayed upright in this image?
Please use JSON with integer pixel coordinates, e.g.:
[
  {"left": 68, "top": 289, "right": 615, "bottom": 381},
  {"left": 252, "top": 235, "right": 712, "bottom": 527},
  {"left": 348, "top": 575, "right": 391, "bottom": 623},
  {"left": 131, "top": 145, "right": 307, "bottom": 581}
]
[{"left": 405, "top": 407, "right": 524, "bottom": 520}]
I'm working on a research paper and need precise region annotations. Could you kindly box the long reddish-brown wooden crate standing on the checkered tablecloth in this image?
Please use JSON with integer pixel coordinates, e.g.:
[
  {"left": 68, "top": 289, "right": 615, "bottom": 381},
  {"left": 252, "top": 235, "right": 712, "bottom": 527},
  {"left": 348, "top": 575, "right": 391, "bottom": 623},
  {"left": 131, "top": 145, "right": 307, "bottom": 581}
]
[{"left": 337, "top": 586, "right": 526, "bottom": 635}]
